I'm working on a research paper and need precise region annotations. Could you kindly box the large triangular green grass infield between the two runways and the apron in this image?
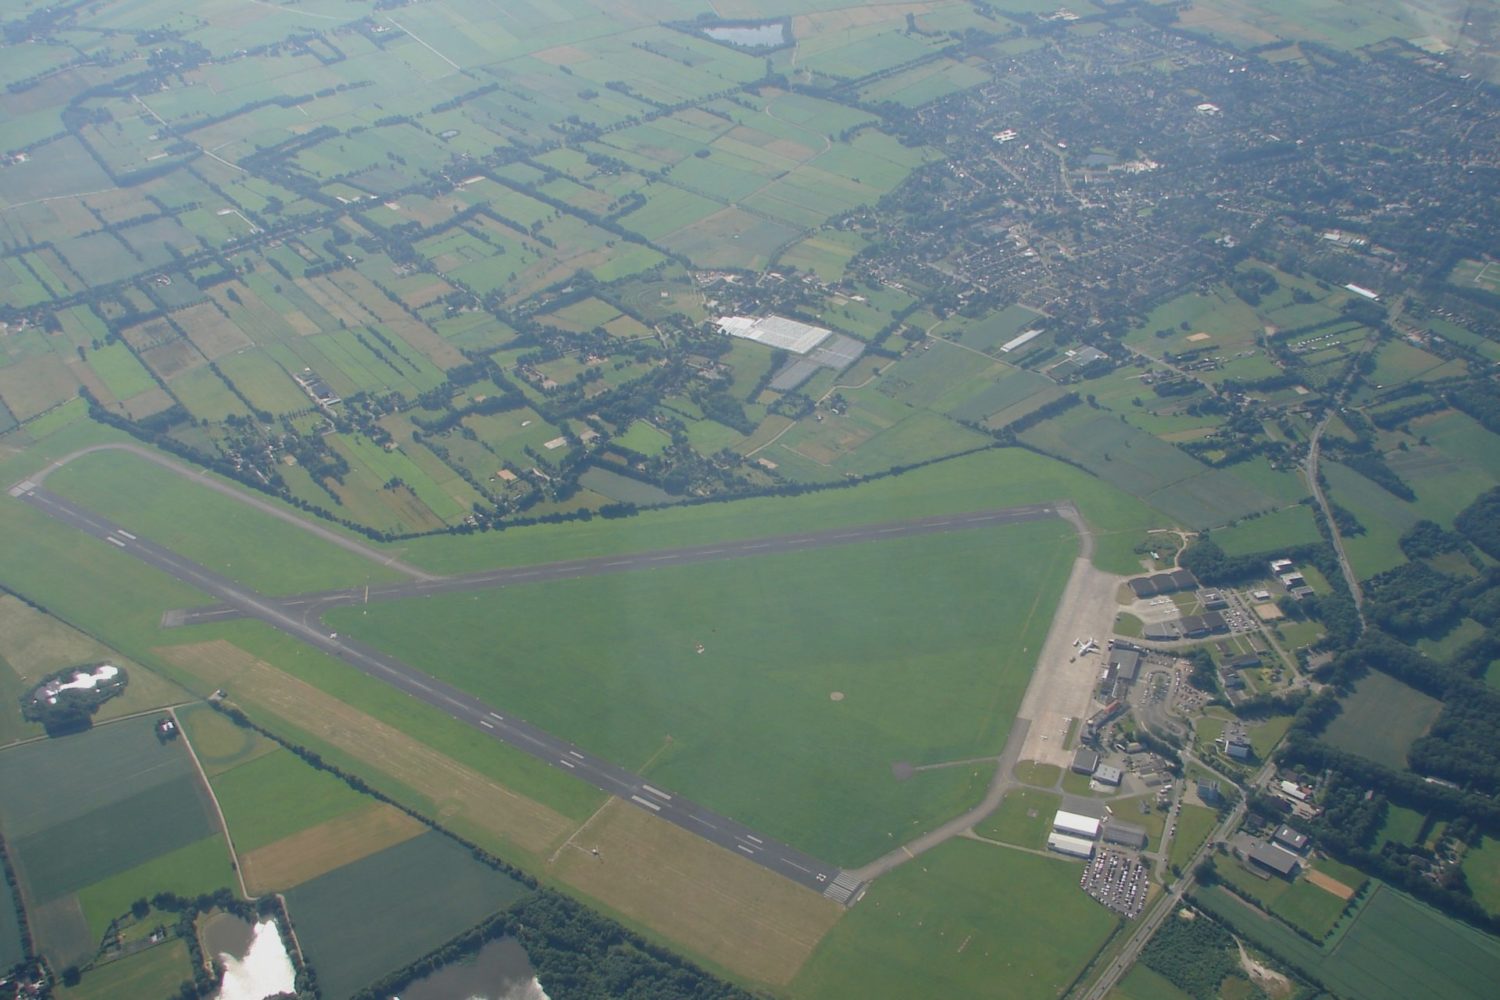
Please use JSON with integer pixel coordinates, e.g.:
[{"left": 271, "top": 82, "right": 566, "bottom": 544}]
[{"left": 329, "top": 520, "right": 1076, "bottom": 861}]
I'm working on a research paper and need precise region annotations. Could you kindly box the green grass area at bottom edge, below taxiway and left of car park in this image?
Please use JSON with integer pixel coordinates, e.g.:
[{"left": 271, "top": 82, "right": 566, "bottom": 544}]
[{"left": 789, "top": 840, "right": 1116, "bottom": 1000}]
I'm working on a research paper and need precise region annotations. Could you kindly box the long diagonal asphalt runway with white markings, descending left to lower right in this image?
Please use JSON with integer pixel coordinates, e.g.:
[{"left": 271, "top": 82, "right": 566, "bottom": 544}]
[{"left": 11, "top": 480, "right": 861, "bottom": 903}]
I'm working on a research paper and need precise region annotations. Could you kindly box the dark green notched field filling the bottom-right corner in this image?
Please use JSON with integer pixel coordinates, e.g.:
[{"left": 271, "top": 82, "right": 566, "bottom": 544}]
[{"left": 1194, "top": 885, "right": 1500, "bottom": 1000}]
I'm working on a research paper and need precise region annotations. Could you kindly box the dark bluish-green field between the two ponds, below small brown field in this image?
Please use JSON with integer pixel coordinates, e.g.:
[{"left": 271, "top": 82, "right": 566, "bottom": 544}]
[{"left": 287, "top": 834, "right": 527, "bottom": 997}]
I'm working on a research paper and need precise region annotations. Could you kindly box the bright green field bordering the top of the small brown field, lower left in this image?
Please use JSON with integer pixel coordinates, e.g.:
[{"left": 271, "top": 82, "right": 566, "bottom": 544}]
[{"left": 213, "top": 750, "right": 369, "bottom": 853}]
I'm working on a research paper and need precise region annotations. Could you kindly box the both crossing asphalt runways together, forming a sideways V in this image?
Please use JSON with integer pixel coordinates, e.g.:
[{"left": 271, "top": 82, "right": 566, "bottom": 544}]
[{"left": 11, "top": 481, "right": 1055, "bottom": 904}]
